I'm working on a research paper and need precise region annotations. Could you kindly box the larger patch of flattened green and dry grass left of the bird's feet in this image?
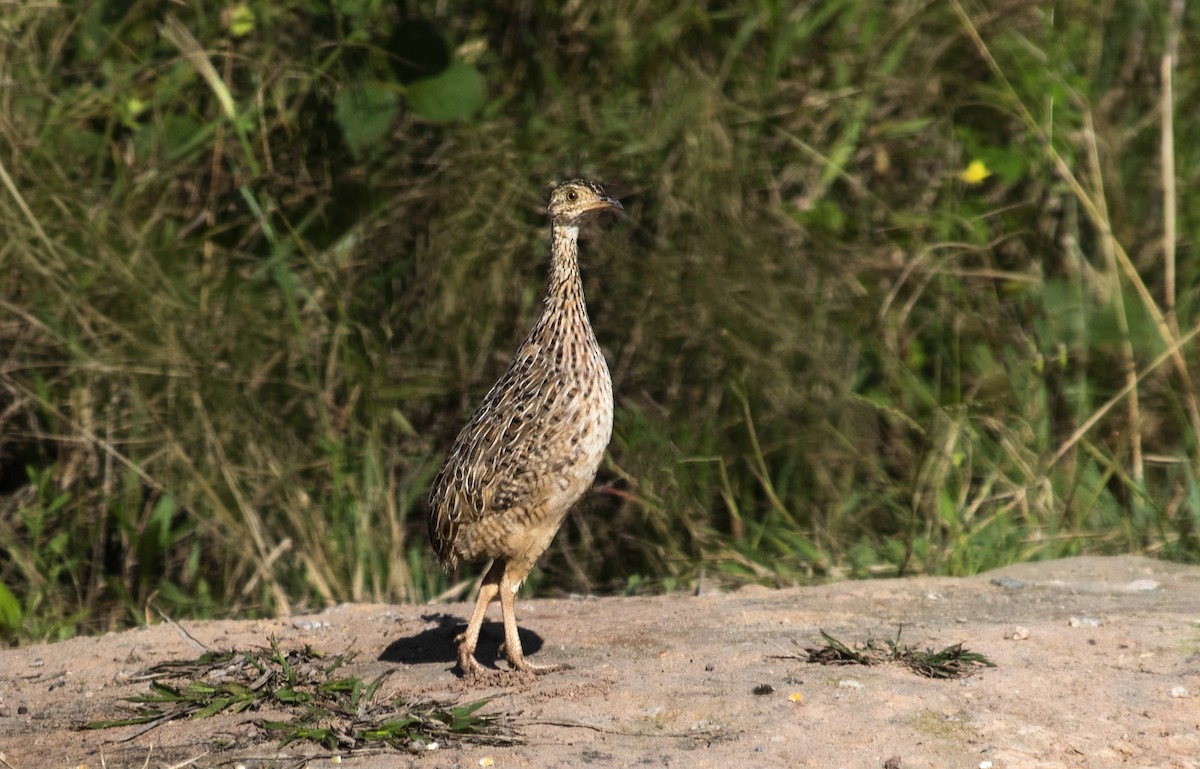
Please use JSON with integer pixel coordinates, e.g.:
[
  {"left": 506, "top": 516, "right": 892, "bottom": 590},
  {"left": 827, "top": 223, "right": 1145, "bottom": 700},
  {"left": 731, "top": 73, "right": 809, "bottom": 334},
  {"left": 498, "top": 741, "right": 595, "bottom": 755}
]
[{"left": 83, "top": 637, "right": 520, "bottom": 752}]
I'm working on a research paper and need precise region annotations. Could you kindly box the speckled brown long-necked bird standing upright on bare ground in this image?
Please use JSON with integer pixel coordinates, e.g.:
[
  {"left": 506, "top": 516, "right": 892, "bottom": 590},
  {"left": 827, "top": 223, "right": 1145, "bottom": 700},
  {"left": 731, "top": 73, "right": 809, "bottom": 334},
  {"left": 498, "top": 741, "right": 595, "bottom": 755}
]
[{"left": 428, "top": 179, "right": 622, "bottom": 678}]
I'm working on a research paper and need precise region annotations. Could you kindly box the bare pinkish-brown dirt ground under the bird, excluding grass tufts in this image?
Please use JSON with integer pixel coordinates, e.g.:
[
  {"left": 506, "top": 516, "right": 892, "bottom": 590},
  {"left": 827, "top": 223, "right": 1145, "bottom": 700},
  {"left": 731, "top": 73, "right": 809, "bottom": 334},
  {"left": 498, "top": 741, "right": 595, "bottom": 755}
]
[{"left": 0, "top": 557, "right": 1200, "bottom": 769}]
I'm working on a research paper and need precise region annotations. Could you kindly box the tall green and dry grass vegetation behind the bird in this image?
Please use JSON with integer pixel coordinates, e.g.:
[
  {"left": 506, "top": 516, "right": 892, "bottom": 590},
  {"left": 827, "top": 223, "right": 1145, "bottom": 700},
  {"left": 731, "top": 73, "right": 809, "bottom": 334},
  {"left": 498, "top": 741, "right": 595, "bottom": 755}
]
[{"left": 0, "top": 0, "right": 1200, "bottom": 641}]
